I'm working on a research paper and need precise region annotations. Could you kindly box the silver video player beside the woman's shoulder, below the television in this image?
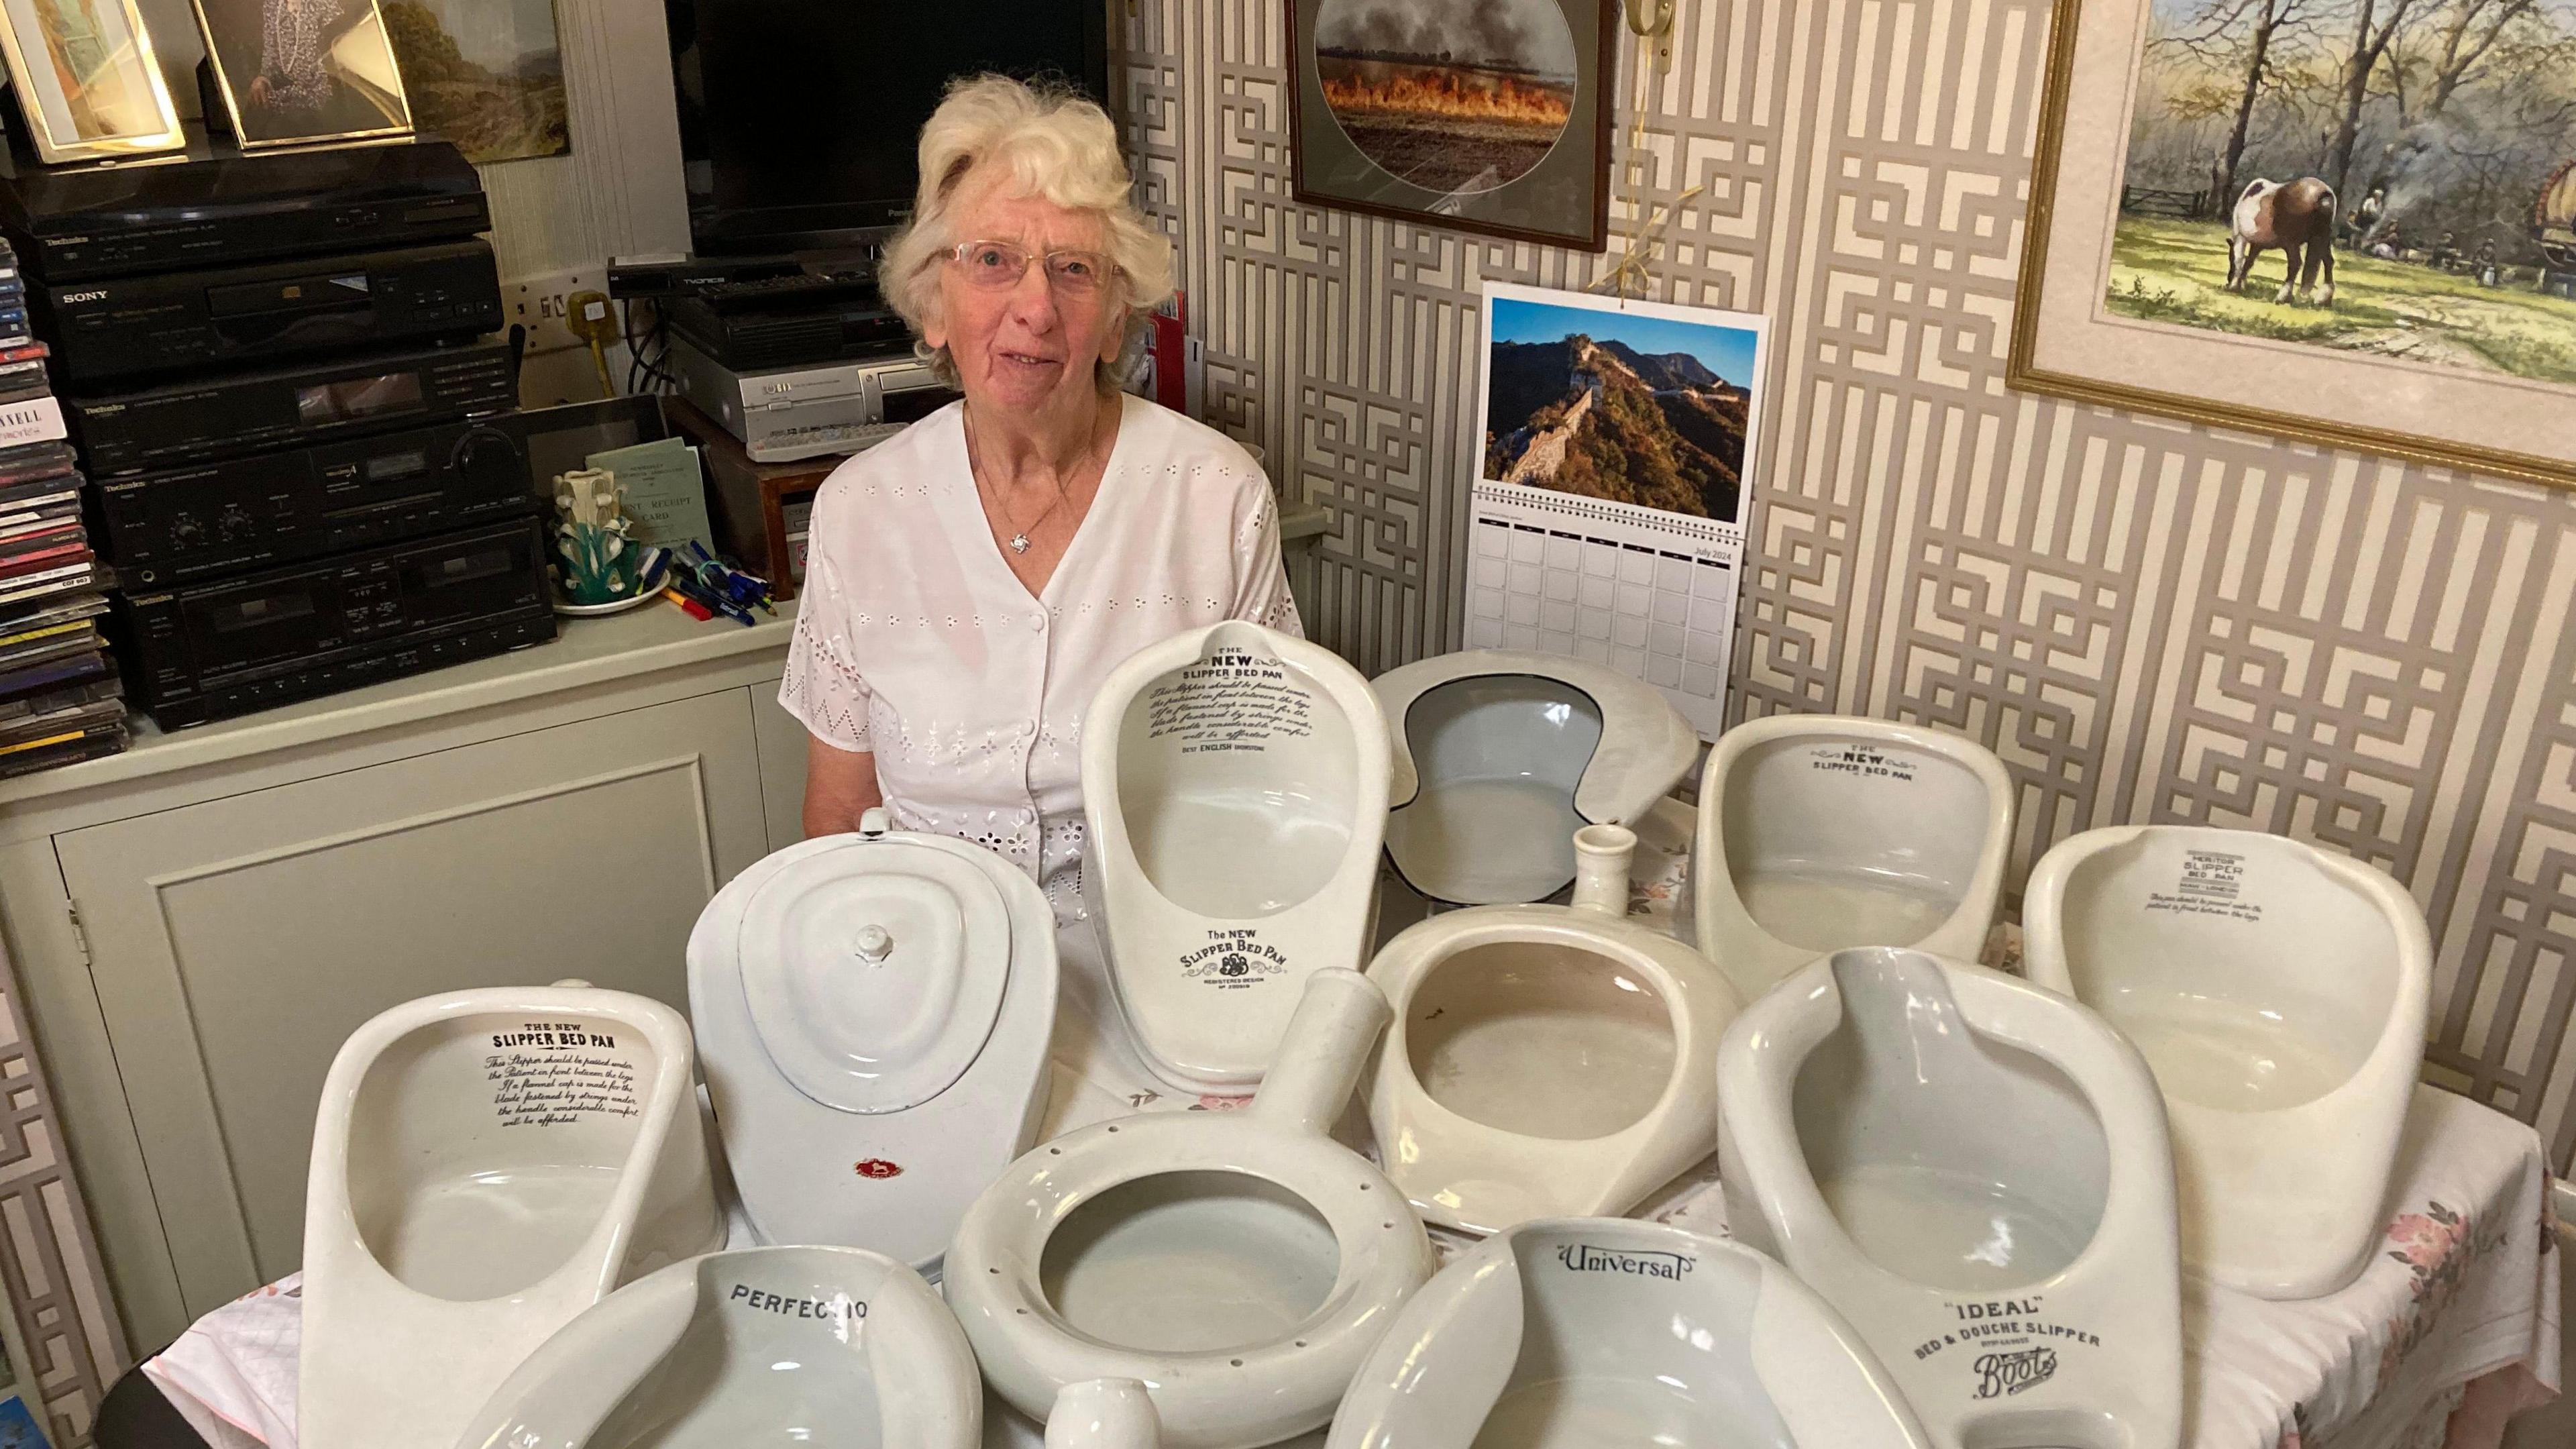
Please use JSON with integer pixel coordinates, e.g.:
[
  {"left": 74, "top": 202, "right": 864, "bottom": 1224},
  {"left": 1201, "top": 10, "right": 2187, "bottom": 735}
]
[{"left": 669, "top": 340, "right": 958, "bottom": 464}]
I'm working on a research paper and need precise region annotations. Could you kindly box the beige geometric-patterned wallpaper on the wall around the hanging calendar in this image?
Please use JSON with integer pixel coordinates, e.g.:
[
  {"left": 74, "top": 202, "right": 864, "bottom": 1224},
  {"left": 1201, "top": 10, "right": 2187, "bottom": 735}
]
[{"left": 1126, "top": 0, "right": 2576, "bottom": 1173}]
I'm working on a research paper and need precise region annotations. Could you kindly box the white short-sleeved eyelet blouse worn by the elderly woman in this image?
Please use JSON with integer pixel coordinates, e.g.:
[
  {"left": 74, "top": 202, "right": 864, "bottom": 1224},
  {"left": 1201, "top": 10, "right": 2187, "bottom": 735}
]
[{"left": 778, "top": 397, "right": 1301, "bottom": 1041}]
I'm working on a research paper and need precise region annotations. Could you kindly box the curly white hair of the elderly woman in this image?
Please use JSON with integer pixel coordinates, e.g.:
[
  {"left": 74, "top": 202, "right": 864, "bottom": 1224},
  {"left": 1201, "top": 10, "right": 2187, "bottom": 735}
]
[{"left": 878, "top": 74, "right": 1172, "bottom": 389}]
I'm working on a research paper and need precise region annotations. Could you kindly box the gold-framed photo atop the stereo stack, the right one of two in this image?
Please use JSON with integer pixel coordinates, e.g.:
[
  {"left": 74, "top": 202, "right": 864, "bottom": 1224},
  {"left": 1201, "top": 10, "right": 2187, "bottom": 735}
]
[{"left": 193, "top": 0, "right": 412, "bottom": 150}]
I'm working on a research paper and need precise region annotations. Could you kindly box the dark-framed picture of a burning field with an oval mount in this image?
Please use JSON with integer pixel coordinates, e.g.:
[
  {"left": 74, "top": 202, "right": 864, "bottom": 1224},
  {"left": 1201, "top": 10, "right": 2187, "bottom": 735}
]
[{"left": 1288, "top": 0, "right": 1618, "bottom": 253}]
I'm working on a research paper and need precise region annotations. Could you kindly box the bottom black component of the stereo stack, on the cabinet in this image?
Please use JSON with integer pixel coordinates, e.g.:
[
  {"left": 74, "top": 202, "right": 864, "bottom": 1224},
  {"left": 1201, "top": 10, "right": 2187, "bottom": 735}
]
[{"left": 116, "top": 519, "right": 554, "bottom": 730}]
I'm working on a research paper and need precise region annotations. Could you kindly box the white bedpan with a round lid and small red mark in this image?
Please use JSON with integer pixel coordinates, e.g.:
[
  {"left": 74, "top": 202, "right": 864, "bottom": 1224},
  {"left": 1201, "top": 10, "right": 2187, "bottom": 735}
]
[{"left": 688, "top": 810, "right": 1056, "bottom": 1274}]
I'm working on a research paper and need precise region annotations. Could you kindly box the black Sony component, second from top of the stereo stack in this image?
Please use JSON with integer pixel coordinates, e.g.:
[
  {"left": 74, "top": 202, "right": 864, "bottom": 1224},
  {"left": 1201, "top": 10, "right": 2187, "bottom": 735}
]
[{"left": 28, "top": 239, "right": 500, "bottom": 387}]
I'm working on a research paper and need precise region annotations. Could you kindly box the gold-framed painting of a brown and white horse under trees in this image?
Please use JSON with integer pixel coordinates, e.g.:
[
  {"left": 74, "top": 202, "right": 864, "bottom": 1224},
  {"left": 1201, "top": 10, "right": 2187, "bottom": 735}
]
[{"left": 2009, "top": 0, "right": 2576, "bottom": 485}]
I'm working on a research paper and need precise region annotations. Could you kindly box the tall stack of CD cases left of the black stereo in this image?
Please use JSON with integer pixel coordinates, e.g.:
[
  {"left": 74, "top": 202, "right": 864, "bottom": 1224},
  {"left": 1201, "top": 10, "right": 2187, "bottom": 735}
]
[{"left": 0, "top": 245, "right": 129, "bottom": 779}]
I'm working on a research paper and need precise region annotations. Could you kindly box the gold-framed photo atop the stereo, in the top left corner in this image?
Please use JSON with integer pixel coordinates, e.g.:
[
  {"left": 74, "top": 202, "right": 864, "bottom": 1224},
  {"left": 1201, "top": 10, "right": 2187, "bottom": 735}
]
[{"left": 0, "top": 0, "right": 185, "bottom": 165}]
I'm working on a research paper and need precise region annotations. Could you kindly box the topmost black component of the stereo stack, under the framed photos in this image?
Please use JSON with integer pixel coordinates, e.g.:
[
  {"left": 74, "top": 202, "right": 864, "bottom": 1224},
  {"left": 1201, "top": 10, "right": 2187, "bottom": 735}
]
[{"left": 0, "top": 140, "right": 492, "bottom": 284}]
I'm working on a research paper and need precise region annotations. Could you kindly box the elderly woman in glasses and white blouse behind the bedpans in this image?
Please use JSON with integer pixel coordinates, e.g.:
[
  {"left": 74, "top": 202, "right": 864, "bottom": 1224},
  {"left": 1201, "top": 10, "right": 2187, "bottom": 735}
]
[{"left": 778, "top": 74, "right": 1298, "bottom": 1103}]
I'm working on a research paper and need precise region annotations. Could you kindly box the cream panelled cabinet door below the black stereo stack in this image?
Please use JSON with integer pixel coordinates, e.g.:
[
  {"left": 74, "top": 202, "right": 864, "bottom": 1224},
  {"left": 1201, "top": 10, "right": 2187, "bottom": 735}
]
[{"left": 54, "top": 688, "right": 767, "bottom": 1315}]
